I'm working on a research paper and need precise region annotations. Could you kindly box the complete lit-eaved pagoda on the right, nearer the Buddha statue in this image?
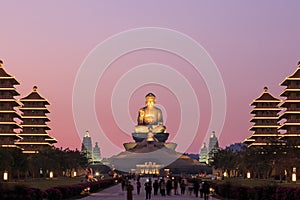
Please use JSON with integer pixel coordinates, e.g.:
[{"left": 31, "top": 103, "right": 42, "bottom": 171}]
[{"left": 244, "top": 87, "right": 284, "bottom": 147}]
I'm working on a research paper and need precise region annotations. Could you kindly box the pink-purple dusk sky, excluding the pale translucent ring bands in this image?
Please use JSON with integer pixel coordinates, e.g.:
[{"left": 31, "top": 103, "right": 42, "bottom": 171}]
[{"left": 0, "top": 0, "right": 300, "bottom": 157}]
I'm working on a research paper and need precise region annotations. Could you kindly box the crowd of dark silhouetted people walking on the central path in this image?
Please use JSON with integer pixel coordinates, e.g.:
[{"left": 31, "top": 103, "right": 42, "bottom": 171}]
[{"left": 121, "top": 177, "right": 210, "bottom": 200}]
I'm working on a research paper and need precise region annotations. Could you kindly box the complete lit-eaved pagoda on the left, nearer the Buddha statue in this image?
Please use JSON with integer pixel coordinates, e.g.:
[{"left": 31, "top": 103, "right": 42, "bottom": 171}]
[{"left": 15, "top": 86, "right": 57, "bottom": 153}]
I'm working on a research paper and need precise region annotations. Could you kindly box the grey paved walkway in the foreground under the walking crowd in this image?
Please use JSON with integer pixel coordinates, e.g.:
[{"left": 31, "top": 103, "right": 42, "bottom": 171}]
[{"left": 81, "top": 179, "right": 218, "bottom": 200}]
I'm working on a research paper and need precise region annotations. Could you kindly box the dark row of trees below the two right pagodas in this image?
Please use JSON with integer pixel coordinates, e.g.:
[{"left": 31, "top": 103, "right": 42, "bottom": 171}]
[{"left": 212, "top": 144, "right": 300, "bottom": 181}]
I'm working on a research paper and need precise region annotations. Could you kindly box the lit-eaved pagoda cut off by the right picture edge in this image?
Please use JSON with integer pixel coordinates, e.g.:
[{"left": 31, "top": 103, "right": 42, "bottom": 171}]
[{"left": 279, "top": 62, "right": 300, "bottom": 148}]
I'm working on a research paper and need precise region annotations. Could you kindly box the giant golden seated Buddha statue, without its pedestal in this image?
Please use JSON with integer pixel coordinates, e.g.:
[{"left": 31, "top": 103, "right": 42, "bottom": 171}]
[{"left": 134, "top": 93, "right": 166, "bottom": 134}]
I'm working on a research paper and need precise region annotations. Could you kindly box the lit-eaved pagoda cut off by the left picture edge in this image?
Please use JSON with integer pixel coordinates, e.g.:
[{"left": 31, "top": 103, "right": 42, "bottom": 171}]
[{"left": 0, "top": 60, "right": 21, "bottom": 147}]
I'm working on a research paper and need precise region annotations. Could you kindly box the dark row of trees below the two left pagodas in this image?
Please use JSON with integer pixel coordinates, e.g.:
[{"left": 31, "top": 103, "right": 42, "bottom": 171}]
[{"left": 0, "top": 147, "right": 88, "bottom": 180}]
